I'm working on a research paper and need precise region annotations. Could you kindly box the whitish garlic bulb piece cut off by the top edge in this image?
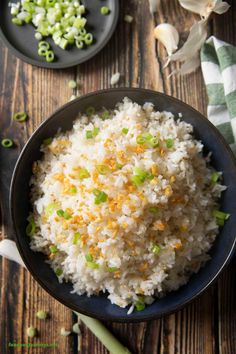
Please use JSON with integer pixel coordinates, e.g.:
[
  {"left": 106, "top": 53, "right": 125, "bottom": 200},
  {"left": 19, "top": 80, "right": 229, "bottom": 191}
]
[{"left": 179, "top": 0, "right": 230, "bottom": 18}]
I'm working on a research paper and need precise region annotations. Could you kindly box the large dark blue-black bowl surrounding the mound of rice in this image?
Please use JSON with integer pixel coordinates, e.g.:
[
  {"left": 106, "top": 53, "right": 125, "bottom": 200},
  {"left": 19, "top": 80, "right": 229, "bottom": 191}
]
[{"left": 10, "top": 88, "right": 236, "bottom": 322}]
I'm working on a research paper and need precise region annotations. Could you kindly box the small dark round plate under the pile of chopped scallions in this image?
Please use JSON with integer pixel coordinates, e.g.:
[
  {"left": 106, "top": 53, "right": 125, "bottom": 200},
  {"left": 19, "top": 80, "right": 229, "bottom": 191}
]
[{"left": 0, "top": 0, "right": 119, "bottom": 69}]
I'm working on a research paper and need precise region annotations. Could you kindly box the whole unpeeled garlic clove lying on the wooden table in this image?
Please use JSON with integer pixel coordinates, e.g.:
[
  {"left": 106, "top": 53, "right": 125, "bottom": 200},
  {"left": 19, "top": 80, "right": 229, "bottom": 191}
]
[{"left": 154, "top": 23, "right": 179, "bottom": 56}]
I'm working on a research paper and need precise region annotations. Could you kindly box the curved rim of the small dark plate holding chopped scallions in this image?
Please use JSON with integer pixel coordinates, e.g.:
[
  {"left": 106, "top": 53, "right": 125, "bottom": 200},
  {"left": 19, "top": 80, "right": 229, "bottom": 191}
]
[{"left": 0, "top": 0, "right": 120, "bottom": 70}]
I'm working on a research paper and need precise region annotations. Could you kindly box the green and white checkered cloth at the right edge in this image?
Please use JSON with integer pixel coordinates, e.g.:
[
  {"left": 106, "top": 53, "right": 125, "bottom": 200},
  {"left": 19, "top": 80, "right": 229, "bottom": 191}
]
[{"left": 201, "top": 36, "right": 236, "bottom": 154}]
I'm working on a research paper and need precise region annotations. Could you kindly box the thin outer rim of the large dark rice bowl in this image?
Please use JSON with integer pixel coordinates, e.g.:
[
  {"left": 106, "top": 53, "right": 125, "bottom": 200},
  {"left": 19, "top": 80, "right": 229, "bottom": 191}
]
[{"left": 9, "top": 87, "right": 236, "bottom": 323}]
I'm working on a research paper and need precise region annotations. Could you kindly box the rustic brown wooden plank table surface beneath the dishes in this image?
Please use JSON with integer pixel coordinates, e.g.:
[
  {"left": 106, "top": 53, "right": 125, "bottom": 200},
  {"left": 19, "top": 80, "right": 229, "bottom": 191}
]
[{"left": 0, "top": 0, "right": 236, "bottom": 354}]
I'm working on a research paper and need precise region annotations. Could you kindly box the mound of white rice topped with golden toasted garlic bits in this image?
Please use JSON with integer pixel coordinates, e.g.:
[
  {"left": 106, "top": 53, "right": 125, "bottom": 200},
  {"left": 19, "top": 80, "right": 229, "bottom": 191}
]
[{"left": 28, "top": 98, "right": 225, "bottom": 313}]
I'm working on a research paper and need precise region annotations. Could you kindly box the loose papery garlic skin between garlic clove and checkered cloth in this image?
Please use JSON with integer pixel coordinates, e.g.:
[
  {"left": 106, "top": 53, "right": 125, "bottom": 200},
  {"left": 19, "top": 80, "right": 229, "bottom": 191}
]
[{"left": 170, "top": 19, "right": 207, "bottom": 75}]
